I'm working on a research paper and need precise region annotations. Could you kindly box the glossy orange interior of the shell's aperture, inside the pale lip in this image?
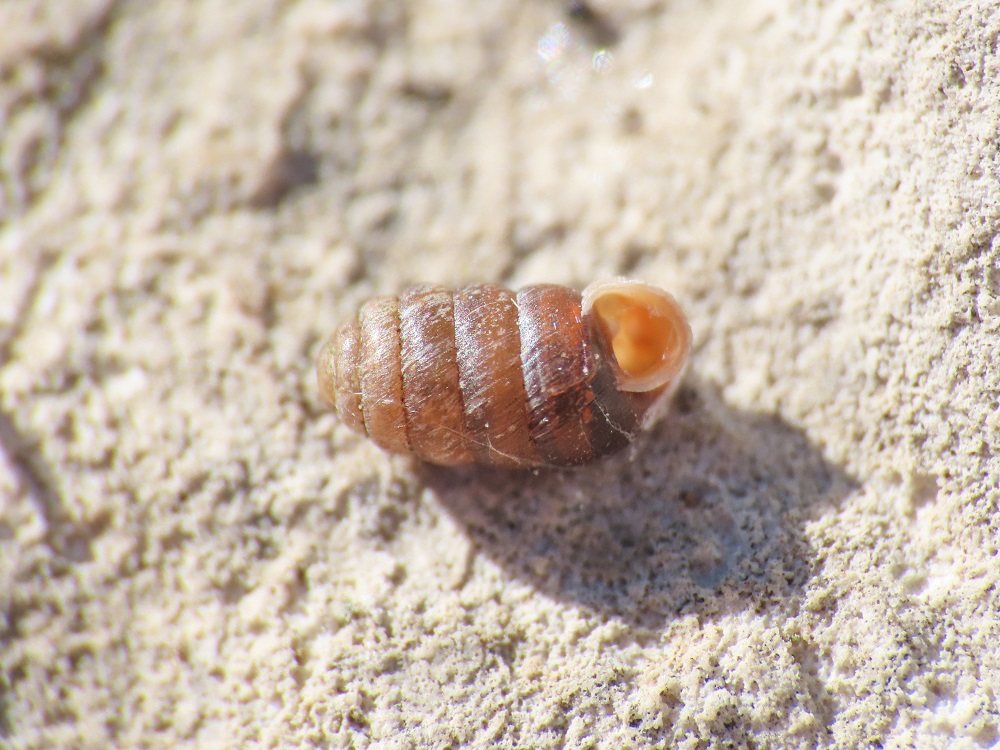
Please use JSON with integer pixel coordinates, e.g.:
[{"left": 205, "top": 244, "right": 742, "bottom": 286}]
[{"left": 593, "top": 292, "right": 678, "bottom": 388}]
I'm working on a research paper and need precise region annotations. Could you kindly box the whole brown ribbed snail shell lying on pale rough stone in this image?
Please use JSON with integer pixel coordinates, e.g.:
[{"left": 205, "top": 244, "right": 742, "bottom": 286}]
[{"left": 317, "top": 279, "right": 691, "bottom": 467}]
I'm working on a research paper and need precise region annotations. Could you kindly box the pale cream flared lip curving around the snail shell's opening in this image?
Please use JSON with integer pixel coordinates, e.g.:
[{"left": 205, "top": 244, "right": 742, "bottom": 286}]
[{"left": 582, "top": 276, "right": 692, "bottom": 393}]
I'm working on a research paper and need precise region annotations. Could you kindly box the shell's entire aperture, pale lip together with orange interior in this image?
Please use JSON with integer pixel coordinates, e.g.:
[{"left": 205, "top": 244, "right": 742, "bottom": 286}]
[{"left": 583, "top": 279, "right": 691, "bottom": 392}]
